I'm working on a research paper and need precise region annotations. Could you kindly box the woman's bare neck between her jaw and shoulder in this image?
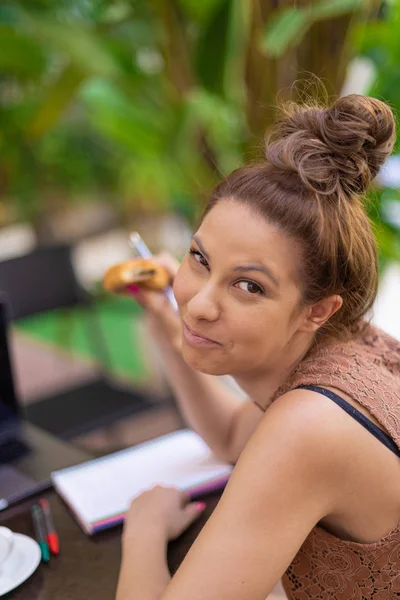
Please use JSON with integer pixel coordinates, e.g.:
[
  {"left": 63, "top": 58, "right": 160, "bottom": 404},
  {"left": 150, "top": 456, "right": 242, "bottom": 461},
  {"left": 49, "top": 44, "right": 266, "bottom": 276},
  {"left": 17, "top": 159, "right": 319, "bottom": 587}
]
[{"left": 232, "top": 335, "right": 313, "bottom": 407}]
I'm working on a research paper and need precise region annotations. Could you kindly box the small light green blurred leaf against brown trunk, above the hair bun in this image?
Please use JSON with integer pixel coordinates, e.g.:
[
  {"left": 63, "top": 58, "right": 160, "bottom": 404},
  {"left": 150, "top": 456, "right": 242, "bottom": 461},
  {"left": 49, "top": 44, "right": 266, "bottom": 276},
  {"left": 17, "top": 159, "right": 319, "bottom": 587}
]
[{"left": 261, "top": 7, "right": 311, "bottom": 57}]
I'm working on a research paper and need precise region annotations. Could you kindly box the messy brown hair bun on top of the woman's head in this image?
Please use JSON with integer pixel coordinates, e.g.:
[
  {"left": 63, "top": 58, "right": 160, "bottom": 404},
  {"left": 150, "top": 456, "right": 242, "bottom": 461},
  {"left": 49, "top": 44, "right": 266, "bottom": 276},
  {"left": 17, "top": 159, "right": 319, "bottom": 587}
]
[{"left": 266, "top": 94, "right": 395, "bottom": 196}]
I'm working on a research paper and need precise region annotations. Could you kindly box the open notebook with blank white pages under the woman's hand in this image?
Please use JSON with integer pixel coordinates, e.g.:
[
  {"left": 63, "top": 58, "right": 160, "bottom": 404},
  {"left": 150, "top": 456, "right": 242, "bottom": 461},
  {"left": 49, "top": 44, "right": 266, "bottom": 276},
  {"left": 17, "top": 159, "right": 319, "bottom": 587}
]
[{"left": 51, "top": 429, "right": 232, "bottom": 535}]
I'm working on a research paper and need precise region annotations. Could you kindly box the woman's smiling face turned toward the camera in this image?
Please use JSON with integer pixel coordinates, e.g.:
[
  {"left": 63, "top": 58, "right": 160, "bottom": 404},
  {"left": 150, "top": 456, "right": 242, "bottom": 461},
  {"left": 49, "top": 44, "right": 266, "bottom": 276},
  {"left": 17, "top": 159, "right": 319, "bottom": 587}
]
[{"left": 174, "top": 199, "right": 308, "bottom": 375}]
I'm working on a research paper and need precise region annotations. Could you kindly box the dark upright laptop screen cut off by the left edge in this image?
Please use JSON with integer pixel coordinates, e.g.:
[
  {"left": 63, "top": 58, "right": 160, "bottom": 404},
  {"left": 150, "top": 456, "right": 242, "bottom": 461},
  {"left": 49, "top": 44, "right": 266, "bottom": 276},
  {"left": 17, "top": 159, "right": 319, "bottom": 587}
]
[{"left": 0, "top": 295, "right": 20, "bottom": 444}]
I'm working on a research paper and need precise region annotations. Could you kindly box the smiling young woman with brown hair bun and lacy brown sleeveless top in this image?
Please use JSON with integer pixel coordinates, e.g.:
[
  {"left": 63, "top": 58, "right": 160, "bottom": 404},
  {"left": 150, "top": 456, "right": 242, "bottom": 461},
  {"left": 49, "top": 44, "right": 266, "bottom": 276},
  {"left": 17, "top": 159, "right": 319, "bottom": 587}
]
[{"left": 117, "top": 95, "right": 400, "bottom": 600}]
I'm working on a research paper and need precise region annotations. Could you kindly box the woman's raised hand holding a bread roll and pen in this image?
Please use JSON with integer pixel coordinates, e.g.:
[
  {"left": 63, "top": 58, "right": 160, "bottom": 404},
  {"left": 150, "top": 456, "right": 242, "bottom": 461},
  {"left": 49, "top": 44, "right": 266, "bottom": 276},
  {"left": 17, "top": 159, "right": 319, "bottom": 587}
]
[{"left": 131, "top": 252, "right": 182, "bottom": 351}]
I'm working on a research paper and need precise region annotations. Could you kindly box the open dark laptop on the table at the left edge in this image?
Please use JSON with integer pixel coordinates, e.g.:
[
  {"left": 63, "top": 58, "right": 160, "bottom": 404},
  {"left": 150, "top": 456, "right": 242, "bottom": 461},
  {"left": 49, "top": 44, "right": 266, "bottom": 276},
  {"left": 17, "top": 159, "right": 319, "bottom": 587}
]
[{"left": 0, "top": 294, "right": 91, "bottom": 510}]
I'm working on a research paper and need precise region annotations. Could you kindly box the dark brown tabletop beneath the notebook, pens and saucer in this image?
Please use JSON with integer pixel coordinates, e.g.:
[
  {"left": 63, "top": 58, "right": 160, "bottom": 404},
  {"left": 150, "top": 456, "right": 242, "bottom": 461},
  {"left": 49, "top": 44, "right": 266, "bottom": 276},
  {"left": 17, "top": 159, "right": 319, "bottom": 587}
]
[{"left": 0, "top": 492, "right": 220, "bottom": 600}]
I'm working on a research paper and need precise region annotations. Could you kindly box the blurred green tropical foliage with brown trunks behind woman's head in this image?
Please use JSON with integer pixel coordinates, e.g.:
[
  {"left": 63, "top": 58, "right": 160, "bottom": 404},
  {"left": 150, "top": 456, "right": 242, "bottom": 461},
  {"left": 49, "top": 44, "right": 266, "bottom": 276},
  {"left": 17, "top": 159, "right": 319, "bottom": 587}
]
[{"left": 0, "top": 0, "right": 400, "bottom": 258}]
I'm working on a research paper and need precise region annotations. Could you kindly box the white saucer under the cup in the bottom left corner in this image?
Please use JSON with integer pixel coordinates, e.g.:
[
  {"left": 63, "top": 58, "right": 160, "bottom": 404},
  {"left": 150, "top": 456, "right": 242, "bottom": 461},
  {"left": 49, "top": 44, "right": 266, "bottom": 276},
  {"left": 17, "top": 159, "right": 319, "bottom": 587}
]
[{"left": 0, "top": 533, "right": 41, "bottom": 596}]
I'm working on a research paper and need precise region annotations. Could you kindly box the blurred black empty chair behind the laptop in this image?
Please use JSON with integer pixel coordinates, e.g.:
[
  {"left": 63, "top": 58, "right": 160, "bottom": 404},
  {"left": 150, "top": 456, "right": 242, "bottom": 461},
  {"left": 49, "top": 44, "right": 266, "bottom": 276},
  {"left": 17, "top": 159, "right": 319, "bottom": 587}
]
[{"left": 0, "top": 245, "right": 164, "bottom": 439}]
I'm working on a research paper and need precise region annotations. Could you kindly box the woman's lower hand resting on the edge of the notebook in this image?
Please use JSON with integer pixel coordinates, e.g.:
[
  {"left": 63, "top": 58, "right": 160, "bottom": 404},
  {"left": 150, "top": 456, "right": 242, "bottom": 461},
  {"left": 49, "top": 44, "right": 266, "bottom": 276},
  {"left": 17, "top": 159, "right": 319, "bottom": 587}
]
[{"left": 123, "top": 485, "right": 206, "bottom": 544}]
